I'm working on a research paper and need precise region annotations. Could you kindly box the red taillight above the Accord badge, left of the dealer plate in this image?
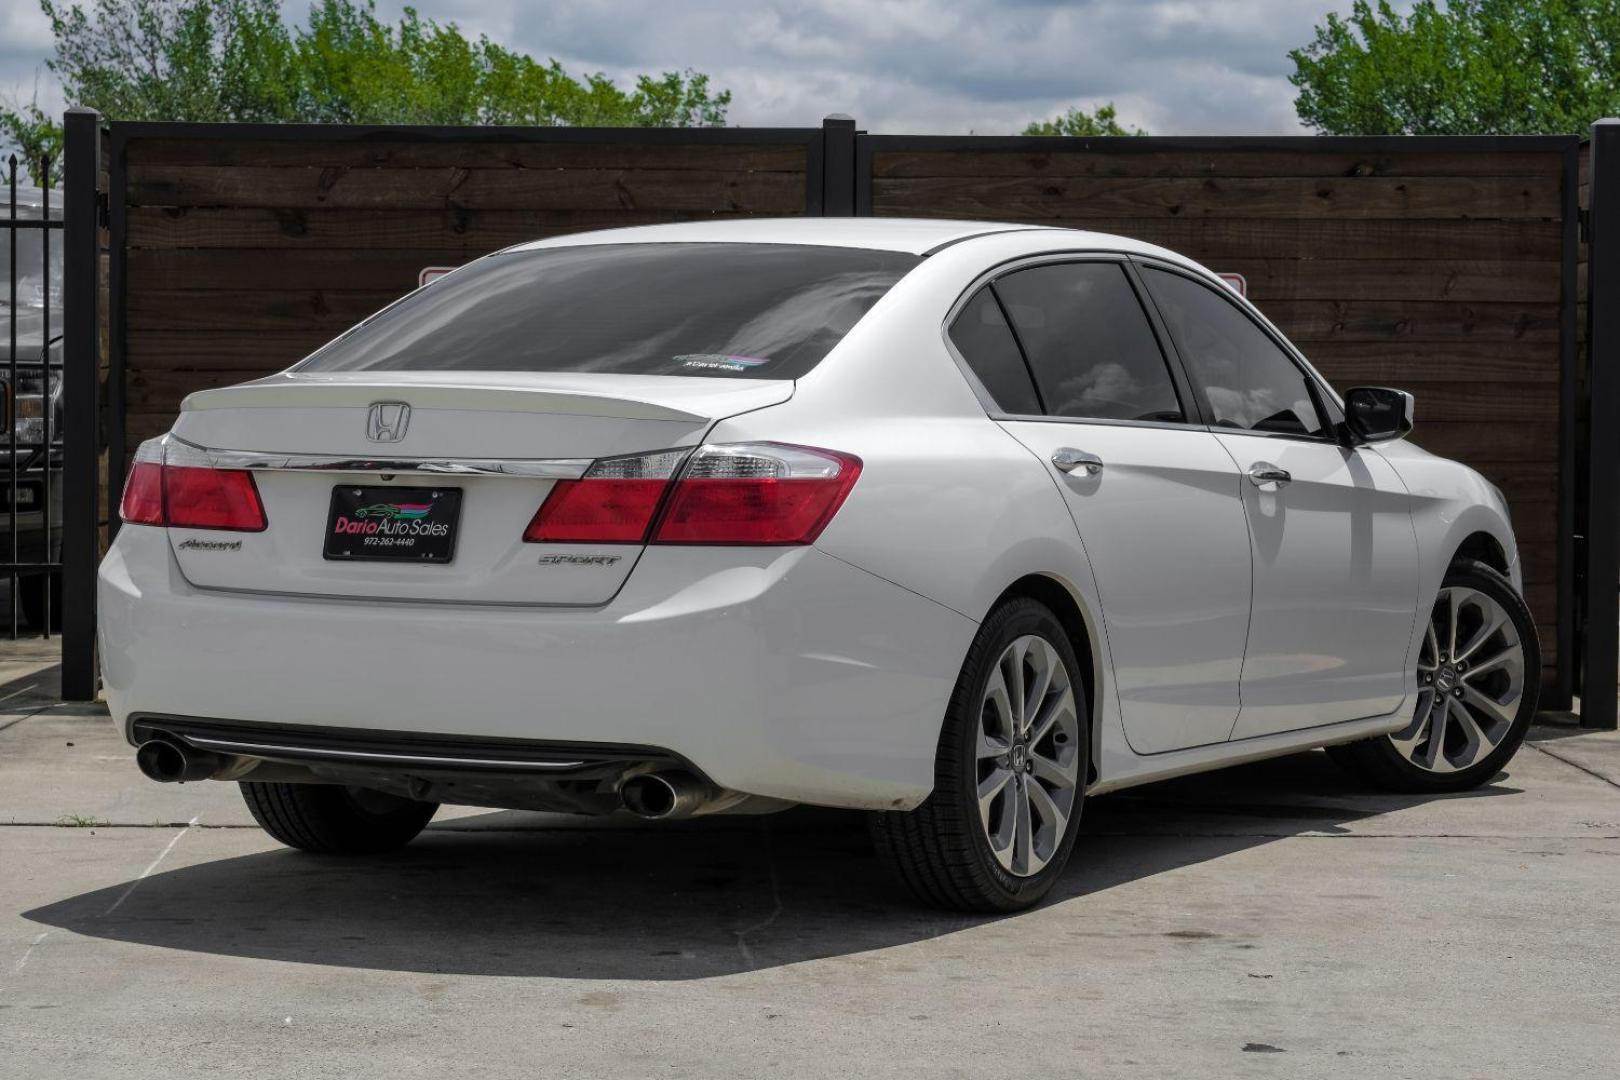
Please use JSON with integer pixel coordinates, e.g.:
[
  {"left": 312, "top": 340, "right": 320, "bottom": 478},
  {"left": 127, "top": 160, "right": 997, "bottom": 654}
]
[{"left": 118, "top": 444, "right": 266, "bottom": 533}]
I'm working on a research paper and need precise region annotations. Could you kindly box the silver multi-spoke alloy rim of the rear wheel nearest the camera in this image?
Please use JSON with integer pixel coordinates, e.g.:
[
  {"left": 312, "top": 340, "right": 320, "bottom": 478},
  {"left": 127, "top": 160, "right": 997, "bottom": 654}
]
[{"left": 975, "top": 635, "right": 1081, "bottom": 878}]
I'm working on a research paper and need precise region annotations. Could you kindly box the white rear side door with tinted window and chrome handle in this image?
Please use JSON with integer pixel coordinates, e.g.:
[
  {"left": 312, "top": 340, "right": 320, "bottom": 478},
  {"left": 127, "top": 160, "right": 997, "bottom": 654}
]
[{"left": 949, "top": 259, "right": 1251, "bottom": 753}]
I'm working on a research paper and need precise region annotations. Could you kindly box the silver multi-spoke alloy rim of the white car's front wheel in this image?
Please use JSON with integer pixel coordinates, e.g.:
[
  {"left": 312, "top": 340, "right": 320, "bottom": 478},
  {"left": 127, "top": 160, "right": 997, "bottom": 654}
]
[{"left": 1390, "top": 586, "right": 1526, "bottom": 772}]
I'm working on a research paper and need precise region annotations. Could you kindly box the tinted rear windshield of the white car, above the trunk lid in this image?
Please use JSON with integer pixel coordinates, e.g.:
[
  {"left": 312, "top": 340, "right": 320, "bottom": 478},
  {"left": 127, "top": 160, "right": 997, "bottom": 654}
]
[{"left": 298, "top": 243, "right": 920, "bottom": 379}]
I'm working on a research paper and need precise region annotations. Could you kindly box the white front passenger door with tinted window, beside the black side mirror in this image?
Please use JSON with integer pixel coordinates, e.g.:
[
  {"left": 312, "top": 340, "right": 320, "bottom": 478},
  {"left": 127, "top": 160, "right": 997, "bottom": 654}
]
[{"left": 1142, "top": 264, "right": 1418, "bottom": 738}]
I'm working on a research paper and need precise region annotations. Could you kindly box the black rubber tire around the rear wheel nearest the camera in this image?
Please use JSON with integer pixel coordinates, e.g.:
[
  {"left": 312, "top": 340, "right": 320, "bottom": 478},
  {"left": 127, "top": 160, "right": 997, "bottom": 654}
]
[{"left": 868, "top": 597, "right": 1090, "bottom": 913}]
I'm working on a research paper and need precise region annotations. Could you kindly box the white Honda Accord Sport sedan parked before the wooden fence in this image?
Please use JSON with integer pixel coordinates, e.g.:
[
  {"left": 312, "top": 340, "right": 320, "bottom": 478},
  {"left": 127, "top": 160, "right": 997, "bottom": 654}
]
[{"left": 99, "top": 219, "right": 1541, "bottom": 910}]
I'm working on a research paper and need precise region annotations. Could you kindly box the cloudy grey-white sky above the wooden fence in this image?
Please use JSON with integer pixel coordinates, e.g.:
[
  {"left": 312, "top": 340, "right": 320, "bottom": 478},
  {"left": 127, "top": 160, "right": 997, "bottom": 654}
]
[{"left": 0, "top": 0, "right": 1347, "bottom": 134}]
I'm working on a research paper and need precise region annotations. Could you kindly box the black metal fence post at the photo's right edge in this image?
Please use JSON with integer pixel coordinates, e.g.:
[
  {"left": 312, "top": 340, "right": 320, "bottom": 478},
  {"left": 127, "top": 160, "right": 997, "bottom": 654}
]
[{"left": 1581, "top": 120, "right": 1620, "bottom": 730}]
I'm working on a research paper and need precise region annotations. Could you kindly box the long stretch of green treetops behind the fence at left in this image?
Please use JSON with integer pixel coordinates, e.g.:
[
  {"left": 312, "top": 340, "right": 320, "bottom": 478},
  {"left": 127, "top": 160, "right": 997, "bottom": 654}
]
[{"left": 0, "top": 0, "right": 731, "bottom": 163}]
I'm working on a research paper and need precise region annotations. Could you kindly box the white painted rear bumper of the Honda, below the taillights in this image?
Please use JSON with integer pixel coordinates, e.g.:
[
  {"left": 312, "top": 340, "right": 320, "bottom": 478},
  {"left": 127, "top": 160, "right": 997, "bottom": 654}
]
[{"left": 99, "top": 526, "right": 975, "bottom": 808}]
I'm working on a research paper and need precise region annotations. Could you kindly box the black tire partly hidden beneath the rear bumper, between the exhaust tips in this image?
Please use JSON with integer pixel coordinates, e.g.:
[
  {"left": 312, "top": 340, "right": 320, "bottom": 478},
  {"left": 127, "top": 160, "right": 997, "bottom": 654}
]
[{"left": 240, "top": 780, "right": 439, "bottom": 855}]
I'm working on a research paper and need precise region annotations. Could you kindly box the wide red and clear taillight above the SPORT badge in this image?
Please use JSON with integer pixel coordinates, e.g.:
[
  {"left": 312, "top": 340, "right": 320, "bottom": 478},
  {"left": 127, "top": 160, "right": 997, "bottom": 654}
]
[{"left": 523, "top": 442, "right": 860, "bottom": 546}]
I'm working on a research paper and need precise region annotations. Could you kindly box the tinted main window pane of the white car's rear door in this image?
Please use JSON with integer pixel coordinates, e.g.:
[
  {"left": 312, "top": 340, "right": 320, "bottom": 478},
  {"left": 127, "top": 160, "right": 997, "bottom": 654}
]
[{"left": 995, "top": 262, "right": 1184, "bottom": 421}]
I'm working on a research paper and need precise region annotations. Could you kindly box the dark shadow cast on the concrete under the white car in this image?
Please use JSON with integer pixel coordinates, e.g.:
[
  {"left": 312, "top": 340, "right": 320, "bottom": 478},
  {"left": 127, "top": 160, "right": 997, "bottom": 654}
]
[{"left": 24, "top": 753, "right": 1516, "bottom": 980}]
